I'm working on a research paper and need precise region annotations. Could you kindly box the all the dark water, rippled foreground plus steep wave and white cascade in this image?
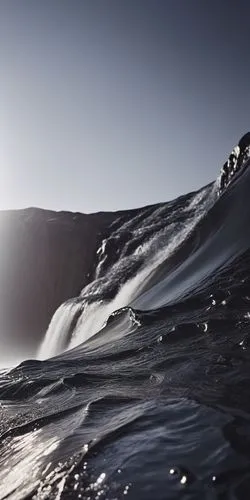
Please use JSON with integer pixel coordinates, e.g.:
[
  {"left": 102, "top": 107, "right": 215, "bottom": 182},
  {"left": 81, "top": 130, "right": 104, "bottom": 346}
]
[{"left": 0, "top": 133, "right": 250, "bottom": 500}]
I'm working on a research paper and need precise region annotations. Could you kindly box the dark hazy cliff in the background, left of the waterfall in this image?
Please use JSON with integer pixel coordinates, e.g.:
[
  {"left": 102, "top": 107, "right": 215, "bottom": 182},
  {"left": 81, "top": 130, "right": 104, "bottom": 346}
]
[{"left": 0, "top": 208, "right": 118, "bottom": 350}]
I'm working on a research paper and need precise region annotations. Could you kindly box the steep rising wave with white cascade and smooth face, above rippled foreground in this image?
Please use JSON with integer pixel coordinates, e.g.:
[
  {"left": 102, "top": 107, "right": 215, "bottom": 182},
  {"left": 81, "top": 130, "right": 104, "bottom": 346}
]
[{"left": 38, "top": 134, "right": 250, "bottom": 359}]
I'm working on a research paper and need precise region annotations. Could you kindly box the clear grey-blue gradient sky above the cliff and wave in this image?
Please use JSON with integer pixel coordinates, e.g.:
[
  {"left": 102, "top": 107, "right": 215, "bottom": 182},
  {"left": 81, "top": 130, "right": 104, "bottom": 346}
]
[{"left": 0, "top": 0, "right": 250, "bottom": 212}]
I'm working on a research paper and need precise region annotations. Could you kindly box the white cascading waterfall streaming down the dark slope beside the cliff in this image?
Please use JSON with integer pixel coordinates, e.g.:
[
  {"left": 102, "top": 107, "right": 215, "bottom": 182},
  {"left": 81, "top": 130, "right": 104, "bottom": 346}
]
[{"left": 38, "top": 185, "right": 217, "bottom": 359}]
